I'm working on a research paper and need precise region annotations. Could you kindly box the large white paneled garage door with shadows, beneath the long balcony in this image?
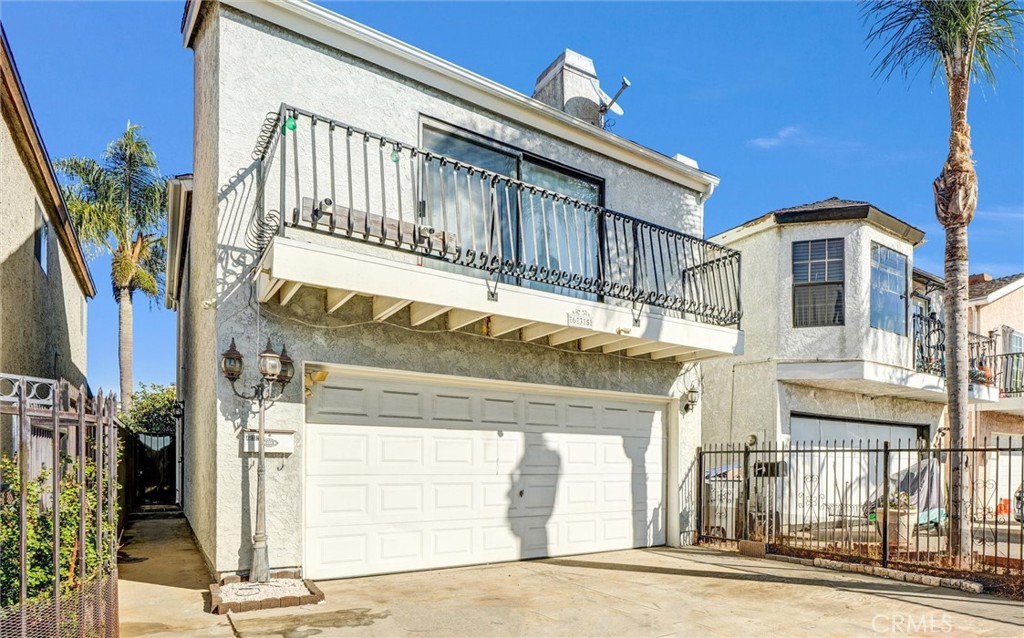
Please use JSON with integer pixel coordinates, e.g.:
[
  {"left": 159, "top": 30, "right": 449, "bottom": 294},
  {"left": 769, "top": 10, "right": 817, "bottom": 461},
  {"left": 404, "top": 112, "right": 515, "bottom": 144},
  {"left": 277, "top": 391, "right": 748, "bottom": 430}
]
[{"left": 304, "top": 373, "right": 666, "bottom": 579}]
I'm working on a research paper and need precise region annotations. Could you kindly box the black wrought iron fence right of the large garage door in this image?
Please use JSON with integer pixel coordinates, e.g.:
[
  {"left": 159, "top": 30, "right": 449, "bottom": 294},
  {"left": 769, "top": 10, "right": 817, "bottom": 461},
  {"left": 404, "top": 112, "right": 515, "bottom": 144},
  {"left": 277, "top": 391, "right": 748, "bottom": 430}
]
[{"left": 696, "top": 436, "right": 1024, "bottom": 579}]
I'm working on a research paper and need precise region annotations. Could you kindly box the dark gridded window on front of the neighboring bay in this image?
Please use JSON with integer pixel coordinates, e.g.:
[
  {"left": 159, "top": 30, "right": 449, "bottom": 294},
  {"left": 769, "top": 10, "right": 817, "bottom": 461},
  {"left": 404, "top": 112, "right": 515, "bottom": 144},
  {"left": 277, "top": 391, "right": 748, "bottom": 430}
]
[{"left": 793, "top": 239, "right": 844, "bottom": 328}]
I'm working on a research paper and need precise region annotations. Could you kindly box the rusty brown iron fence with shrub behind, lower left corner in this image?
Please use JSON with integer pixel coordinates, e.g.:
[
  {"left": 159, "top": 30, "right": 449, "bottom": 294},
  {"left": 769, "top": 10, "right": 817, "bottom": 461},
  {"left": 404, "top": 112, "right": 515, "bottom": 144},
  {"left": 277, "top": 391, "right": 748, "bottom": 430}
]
[{"left": 0, "top": 375, "right": 119, "bottom": 637}]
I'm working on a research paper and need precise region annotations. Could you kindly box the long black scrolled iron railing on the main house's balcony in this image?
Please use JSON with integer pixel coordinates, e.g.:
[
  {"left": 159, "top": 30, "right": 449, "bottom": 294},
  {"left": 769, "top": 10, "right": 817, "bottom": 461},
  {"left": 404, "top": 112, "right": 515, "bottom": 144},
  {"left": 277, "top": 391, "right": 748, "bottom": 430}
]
[{"left": 253, "top": 105, "right": 740, "bottom": 326}]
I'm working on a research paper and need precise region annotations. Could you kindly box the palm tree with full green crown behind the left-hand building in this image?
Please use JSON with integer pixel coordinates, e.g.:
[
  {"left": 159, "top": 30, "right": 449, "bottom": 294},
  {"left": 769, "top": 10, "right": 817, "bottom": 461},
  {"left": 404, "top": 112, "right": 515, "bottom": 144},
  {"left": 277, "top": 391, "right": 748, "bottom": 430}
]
[{"left": 56, "top": 122, "right": 167, "bottom": 411}]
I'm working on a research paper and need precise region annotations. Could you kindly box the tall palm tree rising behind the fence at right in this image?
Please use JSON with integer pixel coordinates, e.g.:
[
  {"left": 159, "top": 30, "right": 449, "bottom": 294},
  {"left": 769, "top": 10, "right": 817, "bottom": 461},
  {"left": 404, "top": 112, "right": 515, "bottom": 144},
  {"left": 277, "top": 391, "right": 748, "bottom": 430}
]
[{"left": 863, "top": 0, "right": 1022, "bottom": 554}]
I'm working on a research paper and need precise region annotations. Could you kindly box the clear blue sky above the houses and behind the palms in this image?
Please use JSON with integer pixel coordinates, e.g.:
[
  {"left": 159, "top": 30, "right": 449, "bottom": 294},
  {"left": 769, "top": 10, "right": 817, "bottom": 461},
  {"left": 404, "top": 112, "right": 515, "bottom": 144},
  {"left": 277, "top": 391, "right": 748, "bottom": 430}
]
[{"left": 0, "top": 0, "right": 1024, "bottom": 395}]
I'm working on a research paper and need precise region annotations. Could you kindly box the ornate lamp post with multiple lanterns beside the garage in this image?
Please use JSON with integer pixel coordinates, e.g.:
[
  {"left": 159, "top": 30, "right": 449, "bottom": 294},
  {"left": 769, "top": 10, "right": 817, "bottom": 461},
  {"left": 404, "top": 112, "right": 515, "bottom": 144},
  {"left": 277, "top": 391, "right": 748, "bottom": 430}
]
[{"left": 220, "top": 339, "right": 295, "bottom": 583}]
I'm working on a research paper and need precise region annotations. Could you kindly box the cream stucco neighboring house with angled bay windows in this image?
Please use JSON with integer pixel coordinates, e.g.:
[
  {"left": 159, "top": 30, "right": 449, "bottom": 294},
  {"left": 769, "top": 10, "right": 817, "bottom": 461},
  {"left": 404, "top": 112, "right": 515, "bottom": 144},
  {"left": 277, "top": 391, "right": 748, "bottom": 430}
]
[{"left": 702, "top": 198, "right": 998, "bottom": 452}]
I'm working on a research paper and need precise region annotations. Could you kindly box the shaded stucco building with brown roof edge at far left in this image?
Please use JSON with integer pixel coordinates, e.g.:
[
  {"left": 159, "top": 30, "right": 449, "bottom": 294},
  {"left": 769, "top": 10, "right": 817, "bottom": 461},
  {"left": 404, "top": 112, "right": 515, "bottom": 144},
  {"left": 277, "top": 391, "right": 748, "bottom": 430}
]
[{"left": 0, "top": 27, "right": 96, "bottom": 389}]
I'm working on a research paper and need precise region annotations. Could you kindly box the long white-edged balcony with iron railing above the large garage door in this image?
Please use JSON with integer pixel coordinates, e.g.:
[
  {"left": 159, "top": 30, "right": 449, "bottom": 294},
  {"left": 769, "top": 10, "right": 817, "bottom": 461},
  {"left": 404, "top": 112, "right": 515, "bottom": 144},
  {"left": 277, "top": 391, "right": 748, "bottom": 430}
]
[{"left": 249, "top": 105, "right": 742, "bottom": 360}]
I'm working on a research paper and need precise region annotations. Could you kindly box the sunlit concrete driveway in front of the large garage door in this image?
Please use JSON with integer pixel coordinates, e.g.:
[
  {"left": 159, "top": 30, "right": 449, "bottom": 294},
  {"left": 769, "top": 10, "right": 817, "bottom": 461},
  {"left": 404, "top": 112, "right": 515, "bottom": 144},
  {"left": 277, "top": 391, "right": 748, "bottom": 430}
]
[{"left": 121, "top": 521, "right": 1024, "bottom": 638}]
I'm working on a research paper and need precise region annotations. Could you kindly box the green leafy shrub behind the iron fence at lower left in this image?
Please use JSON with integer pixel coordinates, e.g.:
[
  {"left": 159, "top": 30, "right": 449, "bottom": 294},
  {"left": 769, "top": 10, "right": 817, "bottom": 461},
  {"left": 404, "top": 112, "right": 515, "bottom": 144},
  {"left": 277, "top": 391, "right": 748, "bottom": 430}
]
[{"left": 0, "top": 456, "right": 118, "bottom": 607}]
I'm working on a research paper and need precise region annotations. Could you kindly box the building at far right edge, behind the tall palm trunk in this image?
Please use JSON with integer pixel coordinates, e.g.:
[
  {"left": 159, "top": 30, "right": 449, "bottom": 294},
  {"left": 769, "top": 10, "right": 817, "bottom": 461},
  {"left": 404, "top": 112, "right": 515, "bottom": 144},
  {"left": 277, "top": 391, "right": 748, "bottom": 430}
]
[{"left": 968, "top": 272, "right": 1024, "bottom": 510}]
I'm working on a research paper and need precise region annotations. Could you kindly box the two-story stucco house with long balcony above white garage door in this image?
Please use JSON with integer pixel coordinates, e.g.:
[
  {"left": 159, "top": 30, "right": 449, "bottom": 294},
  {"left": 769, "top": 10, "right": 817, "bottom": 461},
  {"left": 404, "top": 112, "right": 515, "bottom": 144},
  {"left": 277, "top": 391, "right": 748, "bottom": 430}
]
[{"left": 167, "top": 0, "right": 743, "bottom": 579}]
